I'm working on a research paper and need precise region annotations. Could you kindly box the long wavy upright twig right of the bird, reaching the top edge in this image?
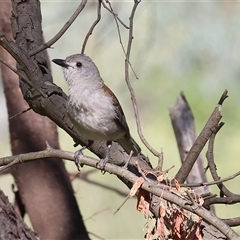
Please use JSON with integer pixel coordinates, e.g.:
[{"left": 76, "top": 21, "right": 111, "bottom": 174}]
[{"left": 125, "top": 0, "right": 161, "bottom": 158}]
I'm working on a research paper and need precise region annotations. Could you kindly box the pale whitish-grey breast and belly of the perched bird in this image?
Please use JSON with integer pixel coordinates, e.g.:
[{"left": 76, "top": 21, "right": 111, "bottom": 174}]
[{"left": 67, "top": 88, "right": 125, "bottom": 141}]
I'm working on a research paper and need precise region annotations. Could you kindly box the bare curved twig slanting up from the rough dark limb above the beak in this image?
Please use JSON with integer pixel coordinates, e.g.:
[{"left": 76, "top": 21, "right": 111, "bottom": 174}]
[{"left": 29, "top": 0, "right": 87, "bottom": 57}]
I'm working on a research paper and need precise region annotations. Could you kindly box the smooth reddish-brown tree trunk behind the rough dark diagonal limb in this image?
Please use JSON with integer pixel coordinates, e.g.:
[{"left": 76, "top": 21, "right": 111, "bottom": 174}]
[{"left": 0, "top": 1, "right": 89, "bottom": 239}]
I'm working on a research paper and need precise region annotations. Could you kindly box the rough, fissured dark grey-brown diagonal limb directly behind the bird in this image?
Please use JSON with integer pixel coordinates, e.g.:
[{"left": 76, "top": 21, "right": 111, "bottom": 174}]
[{"left": 0, "top": 0, "right": 236, "bottom": 239}]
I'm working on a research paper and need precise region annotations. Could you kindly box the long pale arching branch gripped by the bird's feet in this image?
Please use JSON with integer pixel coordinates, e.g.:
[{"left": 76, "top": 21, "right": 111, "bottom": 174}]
[{"left": 0, "top": 146, "right": 240, "bottom": 240}]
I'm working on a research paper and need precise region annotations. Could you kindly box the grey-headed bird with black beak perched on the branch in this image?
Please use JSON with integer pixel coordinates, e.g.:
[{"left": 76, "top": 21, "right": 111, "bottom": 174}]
[{"left": 52, "top": 54, "right": 141, "bottom": 169}]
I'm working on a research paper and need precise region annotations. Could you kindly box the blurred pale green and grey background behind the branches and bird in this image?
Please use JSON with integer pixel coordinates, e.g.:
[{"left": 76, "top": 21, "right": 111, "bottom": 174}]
[{"left": 0, "top": 1, "right": 240, "bottom": 239}]
